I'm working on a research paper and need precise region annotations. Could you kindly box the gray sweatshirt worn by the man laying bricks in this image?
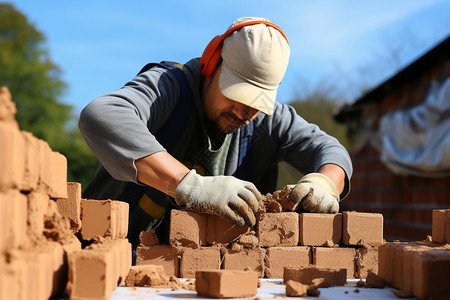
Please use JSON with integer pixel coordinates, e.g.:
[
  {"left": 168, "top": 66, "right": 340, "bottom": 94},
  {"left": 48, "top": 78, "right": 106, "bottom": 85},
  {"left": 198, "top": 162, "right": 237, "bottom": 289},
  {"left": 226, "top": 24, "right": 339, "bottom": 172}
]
[{"left": 79, "top": 58, "right": 353, "bottom": 199}]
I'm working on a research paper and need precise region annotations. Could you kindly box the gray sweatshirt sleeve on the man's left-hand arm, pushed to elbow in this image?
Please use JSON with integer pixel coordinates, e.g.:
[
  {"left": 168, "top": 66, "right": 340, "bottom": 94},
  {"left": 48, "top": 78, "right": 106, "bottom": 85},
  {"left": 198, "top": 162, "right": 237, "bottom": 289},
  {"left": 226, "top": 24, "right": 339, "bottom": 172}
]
[{"left": 78, "top": 67, "right": 180, "bottom": 183}]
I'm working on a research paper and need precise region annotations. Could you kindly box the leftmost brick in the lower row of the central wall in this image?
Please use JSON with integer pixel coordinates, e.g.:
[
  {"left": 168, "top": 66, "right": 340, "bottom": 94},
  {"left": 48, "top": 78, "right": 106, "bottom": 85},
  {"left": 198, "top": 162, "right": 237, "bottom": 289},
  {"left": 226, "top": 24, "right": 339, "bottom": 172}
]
[{"left": 136, "top": 245, "right": 180, "bottom": 277}]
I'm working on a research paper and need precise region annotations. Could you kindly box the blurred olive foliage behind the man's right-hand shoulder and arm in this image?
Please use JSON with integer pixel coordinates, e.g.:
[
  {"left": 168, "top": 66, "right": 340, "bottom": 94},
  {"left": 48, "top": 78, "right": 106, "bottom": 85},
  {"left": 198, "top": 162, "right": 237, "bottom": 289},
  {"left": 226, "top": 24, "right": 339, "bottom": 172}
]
[{"left": 277, "top": 92, "right": 351, "bottom": 189}]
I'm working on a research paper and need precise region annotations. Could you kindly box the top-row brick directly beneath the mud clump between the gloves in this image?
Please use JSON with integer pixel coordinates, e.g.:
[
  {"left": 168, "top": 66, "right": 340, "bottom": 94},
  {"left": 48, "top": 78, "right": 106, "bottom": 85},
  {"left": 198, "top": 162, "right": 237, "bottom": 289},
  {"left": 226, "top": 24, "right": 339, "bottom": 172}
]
[{"left": 257, "top": 212, "right": 299, "bottom": 247}]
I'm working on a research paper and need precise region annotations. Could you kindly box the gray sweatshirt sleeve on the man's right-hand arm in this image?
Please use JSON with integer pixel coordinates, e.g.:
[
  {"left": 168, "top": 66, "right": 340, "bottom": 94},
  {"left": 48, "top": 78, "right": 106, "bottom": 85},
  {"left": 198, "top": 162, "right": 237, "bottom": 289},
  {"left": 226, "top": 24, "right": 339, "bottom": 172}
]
[{"left": 272, "top": 103, "right": 353, "bottom": 199}]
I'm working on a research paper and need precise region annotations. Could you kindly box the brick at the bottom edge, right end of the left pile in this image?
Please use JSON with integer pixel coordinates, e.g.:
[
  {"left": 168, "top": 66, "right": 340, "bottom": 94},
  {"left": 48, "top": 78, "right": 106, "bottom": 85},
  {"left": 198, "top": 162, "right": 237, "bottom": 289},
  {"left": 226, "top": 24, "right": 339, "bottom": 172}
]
[{"left": 66, "top": 250, "right": 117, "bottom": 300}]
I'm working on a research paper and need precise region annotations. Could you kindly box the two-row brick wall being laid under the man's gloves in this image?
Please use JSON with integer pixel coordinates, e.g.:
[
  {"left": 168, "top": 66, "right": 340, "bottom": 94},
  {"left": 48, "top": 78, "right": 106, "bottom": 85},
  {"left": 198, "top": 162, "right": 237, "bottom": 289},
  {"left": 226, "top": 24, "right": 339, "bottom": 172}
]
[{"left": 137, "top": 199, "right": 383, "bottom": 278}]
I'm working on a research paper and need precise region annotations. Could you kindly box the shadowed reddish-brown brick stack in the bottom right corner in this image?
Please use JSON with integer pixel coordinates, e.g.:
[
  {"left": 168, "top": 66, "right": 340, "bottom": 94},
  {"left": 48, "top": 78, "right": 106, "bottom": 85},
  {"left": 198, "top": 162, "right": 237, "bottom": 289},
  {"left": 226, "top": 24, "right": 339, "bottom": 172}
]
[{"left": 378, "top": 209, "right": 450, "bottom": 299}]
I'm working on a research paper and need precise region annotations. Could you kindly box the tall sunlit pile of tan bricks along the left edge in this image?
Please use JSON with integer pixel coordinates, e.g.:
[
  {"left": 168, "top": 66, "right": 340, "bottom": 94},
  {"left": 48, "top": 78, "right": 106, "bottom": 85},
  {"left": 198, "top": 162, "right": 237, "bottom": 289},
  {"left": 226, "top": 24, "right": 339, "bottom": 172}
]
[{"left": 0, "top": 87, "right": 131, "bottom": 300}]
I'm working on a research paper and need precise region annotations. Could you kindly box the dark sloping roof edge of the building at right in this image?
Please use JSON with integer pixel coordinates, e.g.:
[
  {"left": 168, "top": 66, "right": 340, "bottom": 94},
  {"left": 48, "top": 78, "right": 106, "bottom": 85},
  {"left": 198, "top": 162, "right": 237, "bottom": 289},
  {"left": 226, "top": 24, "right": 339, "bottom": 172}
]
[{"left": 334, "top": 36, "right": 450, "bottom": 123}]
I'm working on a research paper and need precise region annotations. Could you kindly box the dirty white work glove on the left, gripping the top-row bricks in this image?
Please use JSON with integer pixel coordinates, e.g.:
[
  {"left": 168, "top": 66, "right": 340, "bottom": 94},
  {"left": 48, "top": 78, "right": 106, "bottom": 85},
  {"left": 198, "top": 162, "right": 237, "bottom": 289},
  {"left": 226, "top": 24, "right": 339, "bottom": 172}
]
[{"left": 175, "top": 169, "right": 261, "bottom": 226}]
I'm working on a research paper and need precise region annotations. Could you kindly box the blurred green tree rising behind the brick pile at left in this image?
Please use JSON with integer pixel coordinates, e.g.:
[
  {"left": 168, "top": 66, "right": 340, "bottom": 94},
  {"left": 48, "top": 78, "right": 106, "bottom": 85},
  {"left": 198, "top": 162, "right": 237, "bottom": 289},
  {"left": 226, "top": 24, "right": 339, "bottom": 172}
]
[{"left": 0, "top": 3, "right": 97, "bottom": 188}]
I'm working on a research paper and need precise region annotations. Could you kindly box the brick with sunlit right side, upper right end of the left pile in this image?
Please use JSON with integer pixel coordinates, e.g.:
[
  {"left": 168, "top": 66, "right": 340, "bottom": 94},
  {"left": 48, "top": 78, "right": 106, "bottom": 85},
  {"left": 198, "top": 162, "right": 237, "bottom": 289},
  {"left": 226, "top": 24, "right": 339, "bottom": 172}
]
[{"left": 81, "top": 199, "right": 128, "bottom": 240}]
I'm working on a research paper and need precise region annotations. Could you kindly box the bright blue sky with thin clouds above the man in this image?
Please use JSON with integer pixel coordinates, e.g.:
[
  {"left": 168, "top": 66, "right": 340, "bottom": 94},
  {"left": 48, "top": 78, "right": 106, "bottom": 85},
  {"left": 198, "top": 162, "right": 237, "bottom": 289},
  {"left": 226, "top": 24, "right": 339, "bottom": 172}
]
[{"left": 9, "top": 0, "right": 450, "bottom": 115}]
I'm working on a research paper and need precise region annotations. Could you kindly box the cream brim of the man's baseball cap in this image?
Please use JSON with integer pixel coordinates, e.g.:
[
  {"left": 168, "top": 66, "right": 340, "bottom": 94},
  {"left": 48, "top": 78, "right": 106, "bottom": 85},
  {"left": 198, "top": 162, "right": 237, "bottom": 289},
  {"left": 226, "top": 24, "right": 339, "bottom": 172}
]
[{"left": 219, "top": 64, "right": 277, "bottom": 115}]
